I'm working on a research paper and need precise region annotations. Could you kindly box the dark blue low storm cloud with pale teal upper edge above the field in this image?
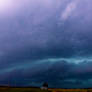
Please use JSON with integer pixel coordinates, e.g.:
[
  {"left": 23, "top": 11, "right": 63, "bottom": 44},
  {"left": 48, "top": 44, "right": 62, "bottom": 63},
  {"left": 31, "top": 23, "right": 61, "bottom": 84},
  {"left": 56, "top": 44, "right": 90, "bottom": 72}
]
[{"left": 0, "top": 60, "right": 92, "bottom": 88}]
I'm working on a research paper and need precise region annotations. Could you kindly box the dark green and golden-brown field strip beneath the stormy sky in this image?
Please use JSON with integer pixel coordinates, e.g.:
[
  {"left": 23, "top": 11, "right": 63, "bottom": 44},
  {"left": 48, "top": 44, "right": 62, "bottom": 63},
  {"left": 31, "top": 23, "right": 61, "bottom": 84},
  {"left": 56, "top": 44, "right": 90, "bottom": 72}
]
[{"left": 0, "top": 87, "right": 92, "bottom": 92}]
